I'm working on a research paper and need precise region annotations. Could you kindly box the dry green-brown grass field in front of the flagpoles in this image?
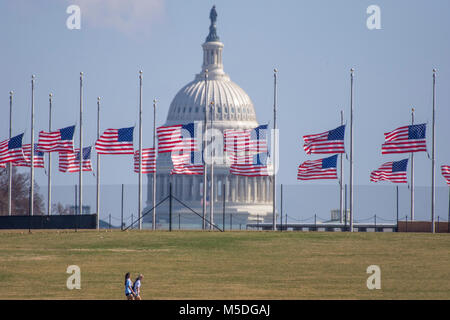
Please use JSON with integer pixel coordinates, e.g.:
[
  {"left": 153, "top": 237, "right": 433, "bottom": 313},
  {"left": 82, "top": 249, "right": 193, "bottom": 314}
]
[{"left": 0, "top": 230, "right": 450, "bottom": 299}]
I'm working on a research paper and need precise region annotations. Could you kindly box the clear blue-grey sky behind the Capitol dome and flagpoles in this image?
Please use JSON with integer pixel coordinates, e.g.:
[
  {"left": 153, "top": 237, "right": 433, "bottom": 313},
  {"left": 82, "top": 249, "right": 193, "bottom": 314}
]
[{"left": 0, "top": 0, "right": 450, "bottom": 220}]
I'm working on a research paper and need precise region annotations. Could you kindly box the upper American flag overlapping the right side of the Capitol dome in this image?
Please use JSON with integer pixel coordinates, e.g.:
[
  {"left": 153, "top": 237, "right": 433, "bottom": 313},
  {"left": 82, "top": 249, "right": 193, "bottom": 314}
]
[{"left": 223, "top": 124, "right": 268, "bottom": 157}]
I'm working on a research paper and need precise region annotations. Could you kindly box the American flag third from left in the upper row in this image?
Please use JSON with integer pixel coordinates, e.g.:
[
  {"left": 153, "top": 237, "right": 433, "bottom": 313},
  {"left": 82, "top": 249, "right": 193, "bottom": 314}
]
[{"left": 95, "top": 127, "right": 134, "bottom": 154}]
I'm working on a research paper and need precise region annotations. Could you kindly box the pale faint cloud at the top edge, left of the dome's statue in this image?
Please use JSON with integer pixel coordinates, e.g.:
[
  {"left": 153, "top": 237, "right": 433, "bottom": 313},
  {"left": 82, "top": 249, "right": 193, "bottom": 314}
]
[{"left": 67, "top": 0, "right": 165, "bottom": 35}]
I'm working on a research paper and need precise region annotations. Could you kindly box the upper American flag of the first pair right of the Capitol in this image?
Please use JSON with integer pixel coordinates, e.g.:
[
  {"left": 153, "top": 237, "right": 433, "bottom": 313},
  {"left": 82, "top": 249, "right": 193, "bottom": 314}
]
[{"left": 303, "top": 125, "right": 345, "bottom": 154}]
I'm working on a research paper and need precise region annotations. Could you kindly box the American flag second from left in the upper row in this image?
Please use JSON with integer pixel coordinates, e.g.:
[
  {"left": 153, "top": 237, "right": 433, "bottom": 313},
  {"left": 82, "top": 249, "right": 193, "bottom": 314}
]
[{"left": 38, "top": 126, "right": 75, "bottom": 152}]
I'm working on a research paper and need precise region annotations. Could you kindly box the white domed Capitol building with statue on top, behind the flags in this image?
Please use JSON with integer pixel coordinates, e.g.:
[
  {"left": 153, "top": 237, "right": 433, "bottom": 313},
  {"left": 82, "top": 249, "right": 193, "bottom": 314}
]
[{"left": 144, "top": 7, "right": 273, "bottom": 228}]
